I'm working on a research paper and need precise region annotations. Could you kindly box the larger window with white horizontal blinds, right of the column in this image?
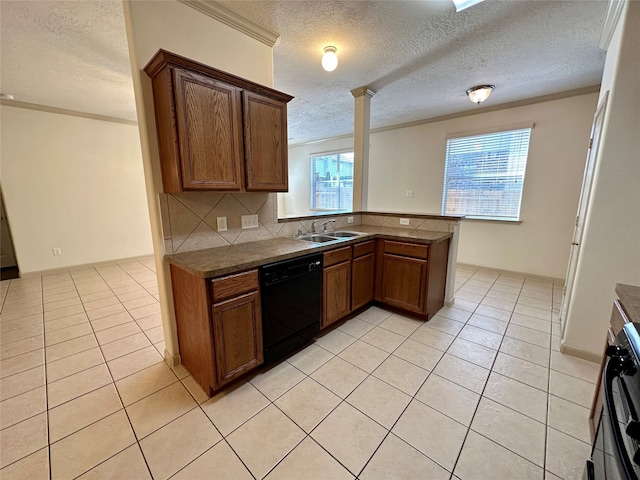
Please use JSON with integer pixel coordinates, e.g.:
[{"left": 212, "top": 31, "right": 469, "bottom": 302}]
[{"left": 442, "top": 127, "right": 531, "bottom": 221}]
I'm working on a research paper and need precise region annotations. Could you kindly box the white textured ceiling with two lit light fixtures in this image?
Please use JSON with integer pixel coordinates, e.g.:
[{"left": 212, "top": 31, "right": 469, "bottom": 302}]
[{"left": 0, "top": 0, "right": 607, "bottom": 143}]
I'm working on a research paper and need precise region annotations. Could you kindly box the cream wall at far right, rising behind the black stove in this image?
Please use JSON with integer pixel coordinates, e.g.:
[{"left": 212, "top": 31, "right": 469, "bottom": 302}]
[{"left": 562, "top": 1, "right": 640, "bottom": 355}]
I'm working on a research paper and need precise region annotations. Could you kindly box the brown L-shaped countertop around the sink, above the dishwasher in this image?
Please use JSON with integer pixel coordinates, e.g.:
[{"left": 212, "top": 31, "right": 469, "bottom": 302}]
[{"left": 165, "top": 225, "right": 453, "bottom": 278}]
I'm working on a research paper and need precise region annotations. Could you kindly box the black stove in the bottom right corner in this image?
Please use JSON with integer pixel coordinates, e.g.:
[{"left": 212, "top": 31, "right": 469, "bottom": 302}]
[{"left": 584, "top": 323, "right": 640, "bottom": 480}]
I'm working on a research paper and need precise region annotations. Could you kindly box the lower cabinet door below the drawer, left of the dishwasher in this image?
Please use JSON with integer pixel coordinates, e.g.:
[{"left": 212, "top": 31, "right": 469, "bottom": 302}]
[{"left": 213, "top": 292, "right": 263, "bottom": 388}]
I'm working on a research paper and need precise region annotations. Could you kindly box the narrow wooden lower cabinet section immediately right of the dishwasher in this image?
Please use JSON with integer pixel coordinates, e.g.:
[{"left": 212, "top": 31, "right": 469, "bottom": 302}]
[{"left": 321, "top": 246, "right": 351, "bottom": 328}]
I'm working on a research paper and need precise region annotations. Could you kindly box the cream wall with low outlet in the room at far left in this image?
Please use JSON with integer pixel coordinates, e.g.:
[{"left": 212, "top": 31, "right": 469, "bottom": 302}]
[{"left": 0, "top": 105, "right": 153, "bottom": 273}]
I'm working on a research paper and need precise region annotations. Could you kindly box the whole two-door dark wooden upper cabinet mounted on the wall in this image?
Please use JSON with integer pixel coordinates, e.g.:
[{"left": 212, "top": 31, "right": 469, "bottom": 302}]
[{"left": 144, "top": 50, "right": 293, "bottom": 193}]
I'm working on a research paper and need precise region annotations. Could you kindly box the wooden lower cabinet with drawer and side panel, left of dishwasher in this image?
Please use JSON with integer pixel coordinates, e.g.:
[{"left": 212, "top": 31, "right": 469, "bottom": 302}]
[{"left": 170, "top": 265, "right": 263, "bottom": 394}]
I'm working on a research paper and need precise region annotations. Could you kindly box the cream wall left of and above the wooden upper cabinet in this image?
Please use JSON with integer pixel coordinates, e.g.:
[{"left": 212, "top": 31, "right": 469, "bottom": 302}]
[{"left": 124, "top": 0, "right": 273, "bottom": 363}]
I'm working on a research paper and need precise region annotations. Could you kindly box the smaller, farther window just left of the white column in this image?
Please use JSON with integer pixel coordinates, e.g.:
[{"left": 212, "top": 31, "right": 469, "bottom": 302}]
[{"left": 310, "top": 152, "right": 353, "bottom": 210}]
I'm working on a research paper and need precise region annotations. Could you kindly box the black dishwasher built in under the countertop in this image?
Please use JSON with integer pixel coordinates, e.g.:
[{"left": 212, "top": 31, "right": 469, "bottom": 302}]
[{"left": 260, "top": 254, "right": 322, "bottom": 363}]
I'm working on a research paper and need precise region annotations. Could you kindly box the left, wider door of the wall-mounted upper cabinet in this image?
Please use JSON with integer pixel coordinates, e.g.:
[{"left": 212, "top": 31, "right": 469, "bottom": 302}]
[{"left": 173, "top": 68, "right": 244, "bottom": 190}]
